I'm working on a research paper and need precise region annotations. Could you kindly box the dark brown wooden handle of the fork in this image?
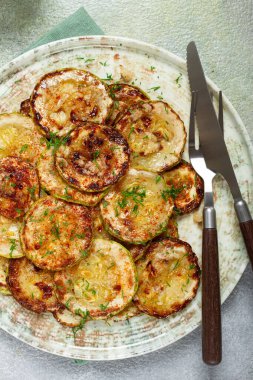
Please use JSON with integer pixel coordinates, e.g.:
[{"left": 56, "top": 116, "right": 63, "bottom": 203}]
[{"left": 202, "top": 228, "right": 222, "bottom": 365}]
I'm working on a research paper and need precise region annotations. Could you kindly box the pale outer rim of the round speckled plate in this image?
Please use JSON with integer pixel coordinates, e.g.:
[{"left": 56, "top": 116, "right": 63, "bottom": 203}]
[{"left": 0, "top": 35, "right": 253, "bottom": 361}]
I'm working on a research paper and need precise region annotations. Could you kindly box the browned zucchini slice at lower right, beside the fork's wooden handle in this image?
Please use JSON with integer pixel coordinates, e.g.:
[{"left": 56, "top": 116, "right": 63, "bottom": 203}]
[{"left": 134, "top": 238, "right": 200, "bottom": 318}]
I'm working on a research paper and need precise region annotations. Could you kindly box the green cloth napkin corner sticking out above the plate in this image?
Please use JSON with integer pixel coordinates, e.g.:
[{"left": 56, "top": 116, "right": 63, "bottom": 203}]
[{"left": 25, "top": 8, "right": 104, "bottom": 51}]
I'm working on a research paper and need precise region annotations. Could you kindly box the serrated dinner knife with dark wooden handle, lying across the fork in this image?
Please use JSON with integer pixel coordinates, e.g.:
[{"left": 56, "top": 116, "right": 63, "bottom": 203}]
[{"left": 187, "top": 41, "right": 253, "bottom": 268}]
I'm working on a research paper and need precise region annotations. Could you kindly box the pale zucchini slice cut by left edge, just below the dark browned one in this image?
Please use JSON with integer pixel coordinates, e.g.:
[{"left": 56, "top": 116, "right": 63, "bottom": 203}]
[{"left": 0, "top": 215, "right": 24, "bottom": 259}]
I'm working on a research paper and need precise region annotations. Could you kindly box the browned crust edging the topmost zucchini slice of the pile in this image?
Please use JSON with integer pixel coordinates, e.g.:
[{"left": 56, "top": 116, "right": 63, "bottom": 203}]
[{"left": 30, "top": 68, "right": 113, "bottom": 137}]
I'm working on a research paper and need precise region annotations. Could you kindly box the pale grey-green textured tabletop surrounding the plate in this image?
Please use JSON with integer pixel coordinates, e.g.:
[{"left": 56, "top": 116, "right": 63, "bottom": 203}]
[{"left": 0, "top": 0, "right": 253, "bottom": 380}]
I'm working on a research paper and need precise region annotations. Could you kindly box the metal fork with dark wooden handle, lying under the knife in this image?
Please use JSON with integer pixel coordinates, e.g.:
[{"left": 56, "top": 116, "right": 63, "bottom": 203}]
[{"left": 188, "top": 91, "right": 223, "bottom": 364}]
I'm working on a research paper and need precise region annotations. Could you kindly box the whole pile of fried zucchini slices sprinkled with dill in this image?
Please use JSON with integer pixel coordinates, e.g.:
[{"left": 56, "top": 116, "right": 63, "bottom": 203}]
[{"left": 0, "top": 68, "right": 203, "bottom": 332}]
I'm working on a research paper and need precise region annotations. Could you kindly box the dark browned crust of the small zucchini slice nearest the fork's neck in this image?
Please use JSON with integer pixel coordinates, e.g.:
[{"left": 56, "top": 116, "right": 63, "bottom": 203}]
[{"left": 164, "top": 160, "right": 204, "bottom": 214}]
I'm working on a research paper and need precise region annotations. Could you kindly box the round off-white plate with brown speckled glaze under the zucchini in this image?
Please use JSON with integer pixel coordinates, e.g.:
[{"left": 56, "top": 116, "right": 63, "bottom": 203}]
[{"left": 0, "top": 36, "right": 253, "bottom": 360}]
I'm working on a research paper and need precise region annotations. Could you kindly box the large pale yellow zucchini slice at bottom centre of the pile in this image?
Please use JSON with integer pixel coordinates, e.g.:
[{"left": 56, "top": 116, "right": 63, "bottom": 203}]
[{"left": 55, "top": 239, "right": 137, "bottom": 319}]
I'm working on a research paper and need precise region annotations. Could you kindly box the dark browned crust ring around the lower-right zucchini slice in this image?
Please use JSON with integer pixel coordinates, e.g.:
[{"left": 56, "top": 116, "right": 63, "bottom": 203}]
[{"left": 133, "top": 238, "right": 201, "bottom": 318}]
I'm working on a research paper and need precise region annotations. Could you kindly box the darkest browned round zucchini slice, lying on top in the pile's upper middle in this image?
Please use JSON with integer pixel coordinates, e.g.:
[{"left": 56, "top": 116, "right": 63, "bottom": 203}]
[{"left": 55, "top": 123, "right": 130, "bottom": 192}]
